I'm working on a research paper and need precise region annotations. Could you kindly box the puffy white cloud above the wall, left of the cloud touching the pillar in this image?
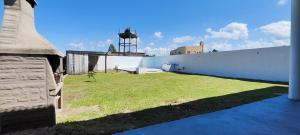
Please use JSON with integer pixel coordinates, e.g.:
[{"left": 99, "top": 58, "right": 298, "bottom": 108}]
[{"left": 205, "top": 22, "right": 249, "bottom": 40}]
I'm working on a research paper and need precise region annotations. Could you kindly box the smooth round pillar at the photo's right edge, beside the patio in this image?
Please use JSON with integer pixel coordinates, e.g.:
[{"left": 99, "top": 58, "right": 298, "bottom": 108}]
[{"left": 289, "top": 0, "right": 300, "bottom": 100}]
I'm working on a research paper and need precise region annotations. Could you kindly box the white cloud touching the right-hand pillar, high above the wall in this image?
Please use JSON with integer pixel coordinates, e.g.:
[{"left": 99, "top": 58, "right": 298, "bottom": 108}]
[{"left": 259, "top": 21, "right": 291, "bottom": 38}]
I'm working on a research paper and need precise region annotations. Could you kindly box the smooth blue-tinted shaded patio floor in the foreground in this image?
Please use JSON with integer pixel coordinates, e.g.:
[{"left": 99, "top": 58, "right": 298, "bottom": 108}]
[{"left": 119, "top": 96, "right": 300, "bottom": 135}]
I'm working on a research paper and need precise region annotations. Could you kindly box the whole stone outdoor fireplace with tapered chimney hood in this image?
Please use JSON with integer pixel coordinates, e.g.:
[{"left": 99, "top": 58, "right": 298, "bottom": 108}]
[{"left": 0, "top": 0, "right": 63, "bottom": 134}]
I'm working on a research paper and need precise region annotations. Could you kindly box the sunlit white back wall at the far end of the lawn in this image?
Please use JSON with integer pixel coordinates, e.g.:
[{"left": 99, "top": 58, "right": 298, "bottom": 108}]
[{"left": 96, "top": 56, "right": 143, "bottom": 71}]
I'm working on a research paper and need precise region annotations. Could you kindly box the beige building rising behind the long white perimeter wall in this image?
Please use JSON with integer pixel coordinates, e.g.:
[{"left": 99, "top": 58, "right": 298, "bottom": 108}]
[{"left": 170, "top": 41, "right": 204, "bottom": 55}]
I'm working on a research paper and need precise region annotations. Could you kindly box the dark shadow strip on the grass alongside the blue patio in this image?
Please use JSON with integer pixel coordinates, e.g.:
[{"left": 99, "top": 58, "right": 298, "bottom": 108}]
[{"left": 56, "top": 86, "right": 288, "bottom": 134}]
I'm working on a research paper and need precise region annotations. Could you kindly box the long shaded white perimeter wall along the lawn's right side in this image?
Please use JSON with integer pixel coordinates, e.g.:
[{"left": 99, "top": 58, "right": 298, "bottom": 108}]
[{"left": 141, "top": 47, "right": 289, "bottom": 82}]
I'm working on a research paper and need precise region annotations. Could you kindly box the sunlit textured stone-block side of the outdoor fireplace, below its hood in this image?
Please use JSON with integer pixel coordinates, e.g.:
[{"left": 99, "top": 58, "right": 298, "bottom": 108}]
[{"left": 0, "top": 55, "right": 48, "bottom": 112}]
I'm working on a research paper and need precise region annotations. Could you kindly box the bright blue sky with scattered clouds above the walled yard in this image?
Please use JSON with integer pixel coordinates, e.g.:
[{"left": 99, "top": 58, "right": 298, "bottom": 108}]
[{"left": 0, "top": 0, "right": 291, "bottom": 55}]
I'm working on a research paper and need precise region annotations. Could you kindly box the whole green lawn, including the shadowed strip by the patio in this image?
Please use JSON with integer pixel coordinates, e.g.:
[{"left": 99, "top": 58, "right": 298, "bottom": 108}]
[{"left": 57, "top": 73, "right": 288, "bottom": 134}]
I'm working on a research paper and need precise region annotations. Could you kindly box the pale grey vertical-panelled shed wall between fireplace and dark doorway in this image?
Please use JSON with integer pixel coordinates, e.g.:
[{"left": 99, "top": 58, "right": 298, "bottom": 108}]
[{"left": 66, "top": 53, "right": 89, "bottom": 75}]
